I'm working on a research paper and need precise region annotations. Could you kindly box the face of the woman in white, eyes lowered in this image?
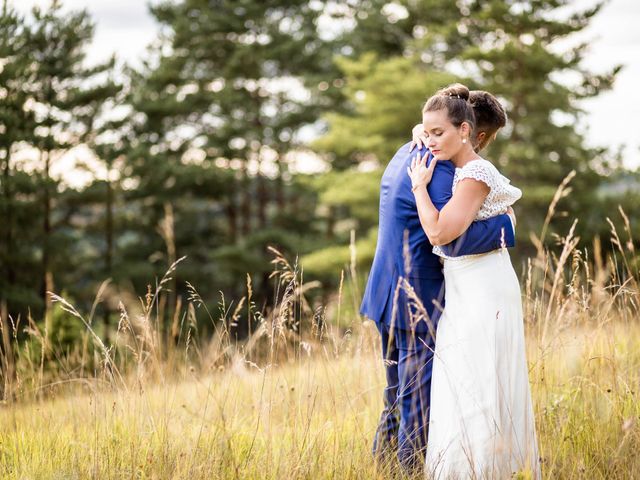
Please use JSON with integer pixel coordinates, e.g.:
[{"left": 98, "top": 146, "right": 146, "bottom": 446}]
[{"left": 422, "top": 109, "right": 469, "bottom": 160}]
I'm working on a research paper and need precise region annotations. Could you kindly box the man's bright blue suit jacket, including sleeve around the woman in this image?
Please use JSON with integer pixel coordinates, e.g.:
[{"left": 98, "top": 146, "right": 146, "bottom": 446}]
[{"left": 360, "top": 143, "right": 514, "bottom": 332}]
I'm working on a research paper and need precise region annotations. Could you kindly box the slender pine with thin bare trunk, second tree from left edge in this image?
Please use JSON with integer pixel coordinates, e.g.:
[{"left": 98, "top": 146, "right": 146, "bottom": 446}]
[{"left": 22, "top": 0, "right": 120, "bottom": 326}]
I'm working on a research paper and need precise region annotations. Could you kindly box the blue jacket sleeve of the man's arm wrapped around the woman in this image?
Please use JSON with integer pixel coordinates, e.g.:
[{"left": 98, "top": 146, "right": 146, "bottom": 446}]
[{"left": 428, "top": 157, "right": 515, "bottom": 257}]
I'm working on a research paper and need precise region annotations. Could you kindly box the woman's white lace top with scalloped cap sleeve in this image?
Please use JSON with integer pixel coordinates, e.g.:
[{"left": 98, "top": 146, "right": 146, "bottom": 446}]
[{"left": 433, "top": 159, "right": 522, "bottom": 260}]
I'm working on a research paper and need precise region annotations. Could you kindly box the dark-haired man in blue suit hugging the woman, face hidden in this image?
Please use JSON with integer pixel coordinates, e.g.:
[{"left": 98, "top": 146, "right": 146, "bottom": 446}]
[{"left": 360, "top": 91, "right": 514, "bottom": 470}]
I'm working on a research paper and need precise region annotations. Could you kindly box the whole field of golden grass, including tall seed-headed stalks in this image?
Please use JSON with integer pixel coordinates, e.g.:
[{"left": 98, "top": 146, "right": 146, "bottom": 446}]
[{"left": 0, "top": 173, "right": 640, "bottom": 480}]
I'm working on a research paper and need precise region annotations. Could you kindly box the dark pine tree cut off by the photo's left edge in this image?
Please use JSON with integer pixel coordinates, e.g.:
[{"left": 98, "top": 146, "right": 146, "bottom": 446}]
[{"left": 0, "top": 0, "right": 37, "bottom": 399}]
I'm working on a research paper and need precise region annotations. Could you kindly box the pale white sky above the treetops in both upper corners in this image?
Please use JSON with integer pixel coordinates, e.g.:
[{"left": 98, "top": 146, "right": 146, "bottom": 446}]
[{"left": 9, "top": 0, "right": 640, "bottom": 178}]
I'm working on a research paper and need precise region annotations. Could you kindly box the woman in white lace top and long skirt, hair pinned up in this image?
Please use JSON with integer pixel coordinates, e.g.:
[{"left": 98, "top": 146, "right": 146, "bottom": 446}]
[{"left": 407, "top": 84, "right": 540, "bottom": 479}]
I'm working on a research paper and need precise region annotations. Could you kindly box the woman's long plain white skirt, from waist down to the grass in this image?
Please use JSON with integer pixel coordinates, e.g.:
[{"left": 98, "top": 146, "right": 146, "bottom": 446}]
[{"left": 425, "top": 249, "right": 540, "bottom": 479}]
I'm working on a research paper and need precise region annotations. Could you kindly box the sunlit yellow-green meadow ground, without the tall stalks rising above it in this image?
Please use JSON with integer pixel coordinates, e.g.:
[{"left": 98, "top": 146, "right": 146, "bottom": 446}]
[{"left": 0, "top": 318, "right": 640, "bottom": 479}]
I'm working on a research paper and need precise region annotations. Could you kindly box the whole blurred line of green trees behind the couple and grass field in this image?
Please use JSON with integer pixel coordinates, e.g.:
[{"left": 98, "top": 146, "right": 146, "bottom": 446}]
[{"left": 0, "top": 0, "right": 637, "bottom": 354}]
